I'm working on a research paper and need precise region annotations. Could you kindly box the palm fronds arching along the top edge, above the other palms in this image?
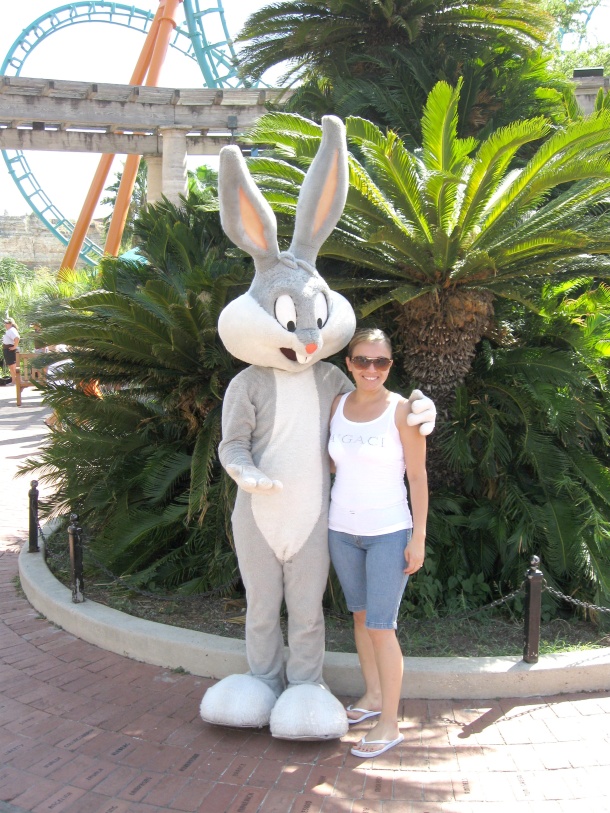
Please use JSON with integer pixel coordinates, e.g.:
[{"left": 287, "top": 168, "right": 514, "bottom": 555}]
[{"left": 240, "top": 0, "right": 552, "bottom": 79}]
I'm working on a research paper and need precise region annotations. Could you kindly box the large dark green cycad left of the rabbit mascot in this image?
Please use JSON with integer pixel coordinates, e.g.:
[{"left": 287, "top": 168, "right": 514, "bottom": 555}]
[{"left": 29, "top": 196, "right": 251, "bottom": 592}]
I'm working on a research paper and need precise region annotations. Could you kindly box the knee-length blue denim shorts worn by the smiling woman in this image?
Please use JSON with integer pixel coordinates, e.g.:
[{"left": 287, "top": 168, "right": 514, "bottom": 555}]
[{"left": 328, "top": 528, "right": 412, "bottom": 629}]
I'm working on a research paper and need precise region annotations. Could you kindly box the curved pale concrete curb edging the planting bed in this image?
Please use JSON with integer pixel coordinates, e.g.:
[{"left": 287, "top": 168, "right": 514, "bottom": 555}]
[{"left": 19, "top": 547, "right": 610, "bottom": 700}]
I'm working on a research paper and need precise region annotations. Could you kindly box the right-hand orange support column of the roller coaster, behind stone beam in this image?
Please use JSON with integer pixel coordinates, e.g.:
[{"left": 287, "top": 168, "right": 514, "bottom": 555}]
[{"left": 104, "top": 0, "right": 182, "bottom": 257}]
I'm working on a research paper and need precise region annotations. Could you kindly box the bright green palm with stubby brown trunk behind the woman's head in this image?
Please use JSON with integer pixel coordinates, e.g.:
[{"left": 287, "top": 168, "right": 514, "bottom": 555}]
[{"left": 245, "top": 82, "right": 610, "bottom": 408}]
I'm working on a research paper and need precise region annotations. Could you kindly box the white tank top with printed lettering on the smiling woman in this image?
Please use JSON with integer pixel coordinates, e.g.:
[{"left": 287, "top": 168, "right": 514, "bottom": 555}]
[{"left": 328, "top": 393, "right": 413, "bottom": 536}]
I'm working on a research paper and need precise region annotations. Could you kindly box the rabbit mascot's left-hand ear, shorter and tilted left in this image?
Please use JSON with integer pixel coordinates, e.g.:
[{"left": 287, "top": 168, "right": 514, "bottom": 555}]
[{"left": 218, "top": 146, "right": 279, "bottom": 271}]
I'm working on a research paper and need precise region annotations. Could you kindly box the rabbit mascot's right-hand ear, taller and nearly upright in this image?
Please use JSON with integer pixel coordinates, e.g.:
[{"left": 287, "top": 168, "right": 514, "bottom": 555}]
[{"left": 290, "top": 116, "right": 349, "bottom": 265}]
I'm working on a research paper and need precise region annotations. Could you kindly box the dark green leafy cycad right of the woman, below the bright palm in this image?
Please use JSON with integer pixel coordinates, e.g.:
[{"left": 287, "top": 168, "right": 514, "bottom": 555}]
[{"left": 439, "top": 280, "right": 610, "bottom": 603}]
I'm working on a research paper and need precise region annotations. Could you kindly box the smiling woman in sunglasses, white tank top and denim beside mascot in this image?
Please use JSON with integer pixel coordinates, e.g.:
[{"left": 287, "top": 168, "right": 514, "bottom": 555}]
[{"left": 328, "top": 329, "right": 428, "bottom": 758}]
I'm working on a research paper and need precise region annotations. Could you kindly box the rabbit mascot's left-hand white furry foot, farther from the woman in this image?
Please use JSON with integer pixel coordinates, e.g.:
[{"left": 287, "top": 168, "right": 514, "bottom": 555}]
[{"left": 199, "top": 675, "right": 277, "bottom": 728}]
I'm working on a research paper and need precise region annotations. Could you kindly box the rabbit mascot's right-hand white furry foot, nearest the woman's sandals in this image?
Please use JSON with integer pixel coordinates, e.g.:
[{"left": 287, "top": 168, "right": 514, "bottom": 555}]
[{"left": 270, "top": 683, "right": 348, "bottom": 740}]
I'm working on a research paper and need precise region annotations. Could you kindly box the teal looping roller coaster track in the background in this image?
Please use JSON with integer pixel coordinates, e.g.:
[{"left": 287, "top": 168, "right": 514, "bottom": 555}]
[{"left": 0, "top": 0, "right": 241, "bottom": 265}]
